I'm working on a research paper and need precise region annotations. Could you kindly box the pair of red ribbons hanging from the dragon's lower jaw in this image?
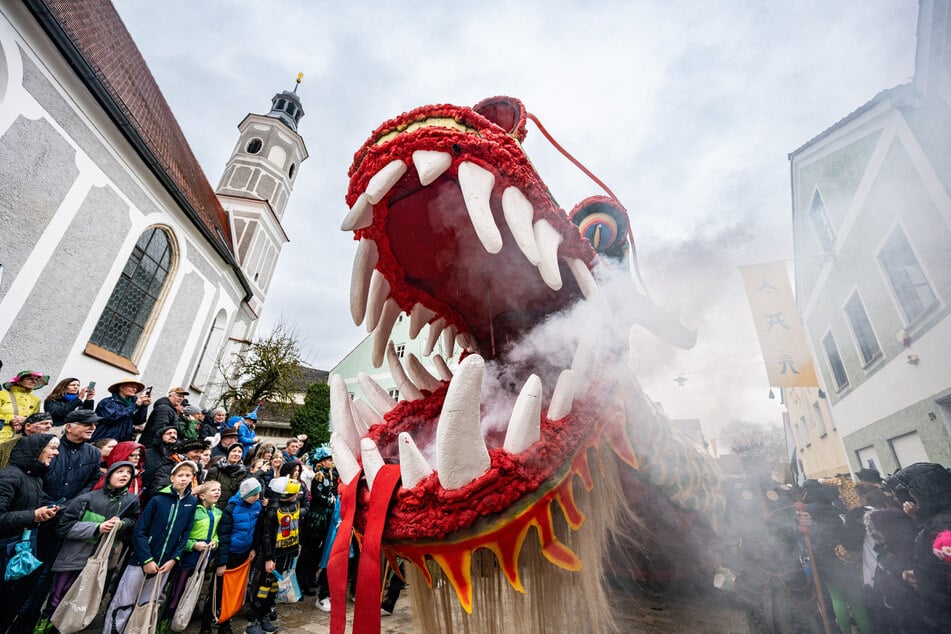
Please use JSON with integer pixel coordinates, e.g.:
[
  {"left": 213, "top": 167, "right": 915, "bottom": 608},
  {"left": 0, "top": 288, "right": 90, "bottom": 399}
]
[{"left": 327, "top": 464, "right": 400, "bottom": 634}]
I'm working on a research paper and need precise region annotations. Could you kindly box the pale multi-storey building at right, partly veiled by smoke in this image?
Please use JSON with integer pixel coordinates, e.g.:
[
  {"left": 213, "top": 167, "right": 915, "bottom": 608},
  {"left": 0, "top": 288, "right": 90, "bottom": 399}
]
[{"left": 789, "top": 0, "right": 951, "bottom": 473}]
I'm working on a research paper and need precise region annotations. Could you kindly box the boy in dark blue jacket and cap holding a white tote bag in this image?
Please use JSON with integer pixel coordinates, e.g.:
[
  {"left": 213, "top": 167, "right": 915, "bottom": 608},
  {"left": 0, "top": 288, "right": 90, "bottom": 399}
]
[{"left": 103, "top": 460, "right": 198, "bottom": 634}]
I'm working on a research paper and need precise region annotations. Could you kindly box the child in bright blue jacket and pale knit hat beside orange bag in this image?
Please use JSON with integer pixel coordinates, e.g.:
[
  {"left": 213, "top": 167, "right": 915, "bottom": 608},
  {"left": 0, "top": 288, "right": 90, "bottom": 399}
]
[{"left": 201, "top": 478, "right": 261, "bottom": 634}]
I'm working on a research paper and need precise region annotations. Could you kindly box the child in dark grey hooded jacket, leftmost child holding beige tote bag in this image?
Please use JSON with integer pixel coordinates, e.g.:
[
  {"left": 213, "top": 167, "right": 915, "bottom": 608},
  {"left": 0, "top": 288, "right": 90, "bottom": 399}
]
[{"left": 36, "top": 462, "right": 139, "bottom": 631}]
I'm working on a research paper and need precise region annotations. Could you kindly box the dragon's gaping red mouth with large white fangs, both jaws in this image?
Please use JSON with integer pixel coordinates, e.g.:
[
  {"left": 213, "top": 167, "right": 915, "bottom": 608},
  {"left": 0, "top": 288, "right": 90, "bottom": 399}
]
[{"left": 331, "top": 97, "right": 708, "bottom": 610}]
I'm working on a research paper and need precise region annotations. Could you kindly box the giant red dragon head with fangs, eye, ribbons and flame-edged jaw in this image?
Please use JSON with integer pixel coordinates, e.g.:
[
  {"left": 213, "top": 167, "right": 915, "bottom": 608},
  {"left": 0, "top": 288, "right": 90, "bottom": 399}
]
[{"left": 331, "top": 97, "right": 722, "bottom": 631}]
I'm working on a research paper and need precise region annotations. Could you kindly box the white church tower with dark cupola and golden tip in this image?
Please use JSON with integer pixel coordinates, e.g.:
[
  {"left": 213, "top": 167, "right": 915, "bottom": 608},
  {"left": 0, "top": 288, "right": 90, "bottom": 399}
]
[{"left": 216, "top": 74, "right": 307, "bottom": 314}]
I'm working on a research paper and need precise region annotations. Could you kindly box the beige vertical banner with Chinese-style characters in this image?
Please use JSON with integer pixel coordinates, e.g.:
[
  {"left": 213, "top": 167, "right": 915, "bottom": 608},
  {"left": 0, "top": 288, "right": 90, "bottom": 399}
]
[{"left": 740, "top": 262, "right": 819, "bottom": 387}]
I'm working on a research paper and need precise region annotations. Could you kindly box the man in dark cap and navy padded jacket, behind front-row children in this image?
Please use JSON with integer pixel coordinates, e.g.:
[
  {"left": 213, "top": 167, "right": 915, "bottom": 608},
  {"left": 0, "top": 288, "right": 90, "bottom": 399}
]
[{"left": 43, "top": 409, "right": 102, "bottom": 504}]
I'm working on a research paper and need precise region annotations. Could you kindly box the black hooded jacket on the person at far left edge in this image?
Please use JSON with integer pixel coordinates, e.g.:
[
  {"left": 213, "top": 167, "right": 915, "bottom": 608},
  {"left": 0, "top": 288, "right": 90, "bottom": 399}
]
[{"left": 0, "top": 434, "right": 54, "bottom": 539}]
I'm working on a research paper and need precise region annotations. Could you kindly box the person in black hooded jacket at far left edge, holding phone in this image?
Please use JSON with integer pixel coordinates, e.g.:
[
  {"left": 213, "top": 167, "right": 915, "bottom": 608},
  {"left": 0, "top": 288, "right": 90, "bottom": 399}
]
[{"left": 0, "top": 434, "right": 59, "bottom": 632}]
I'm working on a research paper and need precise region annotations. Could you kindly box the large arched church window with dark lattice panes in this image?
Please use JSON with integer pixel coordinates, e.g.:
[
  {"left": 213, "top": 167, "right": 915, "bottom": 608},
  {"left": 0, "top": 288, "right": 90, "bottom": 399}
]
[{"left": 86, "top": 227, "right": 176, "bottom": 370}]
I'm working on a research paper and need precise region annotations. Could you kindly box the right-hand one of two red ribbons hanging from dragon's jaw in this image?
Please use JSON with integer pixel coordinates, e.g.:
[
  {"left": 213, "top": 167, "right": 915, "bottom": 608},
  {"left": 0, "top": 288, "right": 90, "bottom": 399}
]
[{"left": 356, "top": 464, "right": 400, "bottom": 633}]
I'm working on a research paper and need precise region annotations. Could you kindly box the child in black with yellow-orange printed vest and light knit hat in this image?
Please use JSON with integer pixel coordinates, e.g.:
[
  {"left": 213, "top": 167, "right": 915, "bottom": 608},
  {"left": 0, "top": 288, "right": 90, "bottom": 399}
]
[{"left": 245, "top": 476, "right": 301, "bottom": 634}]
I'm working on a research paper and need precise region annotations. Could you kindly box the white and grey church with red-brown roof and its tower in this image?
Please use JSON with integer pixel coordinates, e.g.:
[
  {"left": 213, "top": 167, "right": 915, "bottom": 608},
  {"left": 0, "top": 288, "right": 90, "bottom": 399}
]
[{"left": 0, "top": 0, "right": 307, "bottom": 404}]
